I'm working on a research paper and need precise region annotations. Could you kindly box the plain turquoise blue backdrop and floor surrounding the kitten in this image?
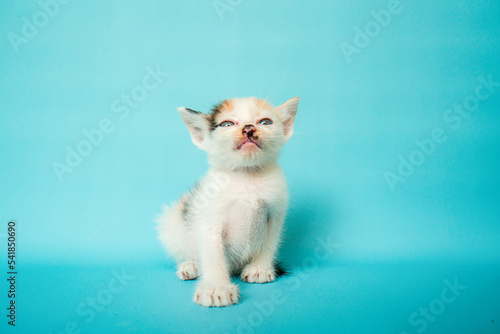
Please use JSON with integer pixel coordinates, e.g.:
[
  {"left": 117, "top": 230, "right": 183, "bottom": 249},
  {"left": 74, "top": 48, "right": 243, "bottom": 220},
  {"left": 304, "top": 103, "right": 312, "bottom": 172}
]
[{"left": 0, "top": 0, "right": 500, "bottom": 334}]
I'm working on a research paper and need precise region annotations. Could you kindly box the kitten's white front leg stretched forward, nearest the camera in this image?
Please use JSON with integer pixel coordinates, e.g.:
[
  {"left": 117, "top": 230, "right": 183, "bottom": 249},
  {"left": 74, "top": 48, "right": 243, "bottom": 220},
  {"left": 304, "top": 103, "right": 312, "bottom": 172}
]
[{"left": 193, "top": 226, "right": 240, "bottom": 307}]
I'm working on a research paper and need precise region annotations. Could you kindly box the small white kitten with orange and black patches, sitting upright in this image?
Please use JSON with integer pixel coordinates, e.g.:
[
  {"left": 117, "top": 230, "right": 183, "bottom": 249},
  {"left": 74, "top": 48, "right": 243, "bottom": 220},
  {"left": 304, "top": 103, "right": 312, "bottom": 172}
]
[{"left": 157, "top": 97, "right": 299, "bottom": 307}]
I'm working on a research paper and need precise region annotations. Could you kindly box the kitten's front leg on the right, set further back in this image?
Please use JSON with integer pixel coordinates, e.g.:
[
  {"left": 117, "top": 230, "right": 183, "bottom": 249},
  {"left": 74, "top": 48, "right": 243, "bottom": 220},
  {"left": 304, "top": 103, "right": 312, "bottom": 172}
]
[{"left": 241, "top": 214, "right": 285, "bottom": 283}]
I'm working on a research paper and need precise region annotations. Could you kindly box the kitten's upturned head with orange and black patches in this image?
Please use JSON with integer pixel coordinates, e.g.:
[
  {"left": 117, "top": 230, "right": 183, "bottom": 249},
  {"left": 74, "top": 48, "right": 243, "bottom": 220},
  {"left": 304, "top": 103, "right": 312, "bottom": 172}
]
[{"left": 178, "top": 97, "right": 299, "bottom": 170}]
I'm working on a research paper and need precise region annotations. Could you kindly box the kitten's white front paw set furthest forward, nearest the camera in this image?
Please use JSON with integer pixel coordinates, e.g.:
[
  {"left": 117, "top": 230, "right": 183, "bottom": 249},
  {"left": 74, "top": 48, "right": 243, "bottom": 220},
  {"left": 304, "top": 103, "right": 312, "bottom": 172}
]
[{"left": 194, "top": 283, "right": 240, "bottom": 307}]
